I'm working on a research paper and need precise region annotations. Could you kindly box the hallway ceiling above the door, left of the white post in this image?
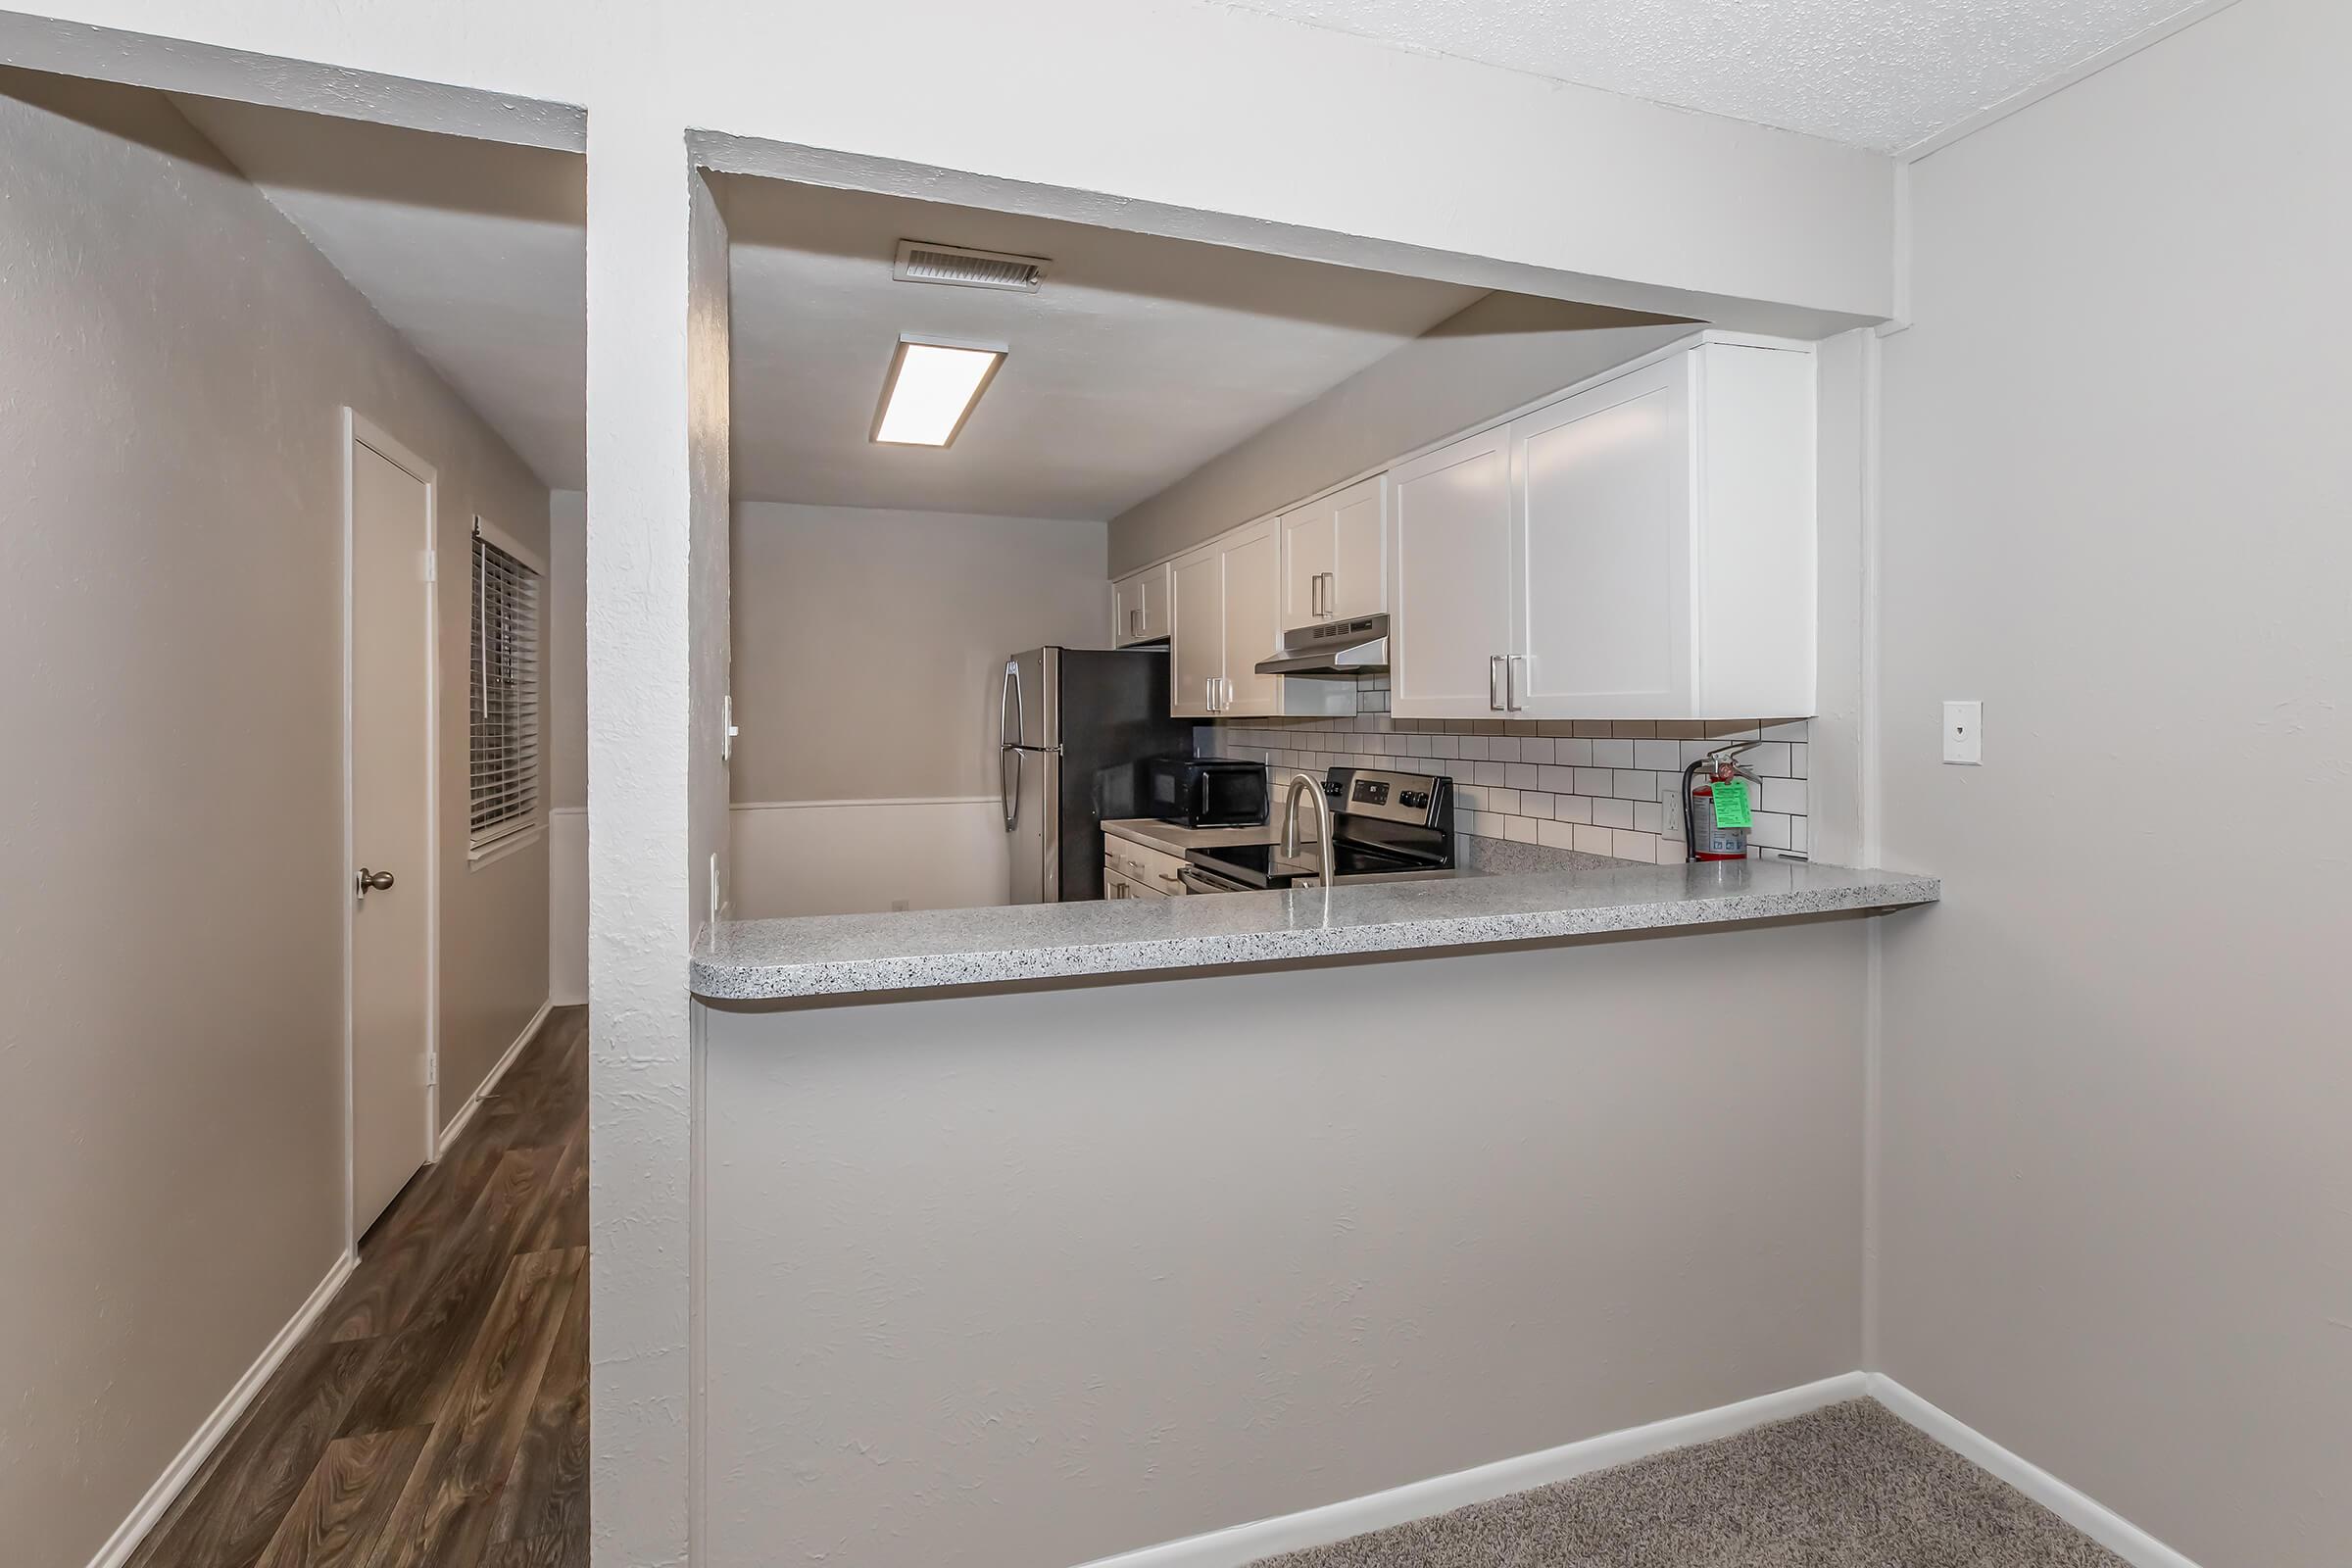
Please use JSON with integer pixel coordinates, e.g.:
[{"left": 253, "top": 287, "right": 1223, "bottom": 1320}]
[{"left": 172, "top": 96, "right": 588, "bottom": 489}]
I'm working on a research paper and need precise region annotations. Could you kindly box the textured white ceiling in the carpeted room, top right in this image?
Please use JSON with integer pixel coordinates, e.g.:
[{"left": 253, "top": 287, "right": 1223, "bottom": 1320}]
[{"left": 1209, "top": 0, "right": 2192, "bottom": 153}]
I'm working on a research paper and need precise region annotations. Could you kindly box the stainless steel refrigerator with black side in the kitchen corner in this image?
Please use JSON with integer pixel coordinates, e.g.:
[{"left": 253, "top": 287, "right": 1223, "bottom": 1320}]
[{"left": 998, "top": 649, "right": 1193, "bottom": 903}]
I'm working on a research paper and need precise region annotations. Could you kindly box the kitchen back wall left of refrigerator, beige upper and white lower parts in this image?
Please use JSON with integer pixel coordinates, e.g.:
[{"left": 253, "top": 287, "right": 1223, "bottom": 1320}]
[{"left": 734, "top": 503, "right": 1110, "bottom": 919}]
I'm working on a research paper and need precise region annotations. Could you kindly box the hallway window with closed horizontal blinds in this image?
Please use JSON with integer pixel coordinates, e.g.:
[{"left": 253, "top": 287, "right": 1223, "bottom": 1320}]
[{"left": 468, "top": 517, "right": 539, "bottom": 854}]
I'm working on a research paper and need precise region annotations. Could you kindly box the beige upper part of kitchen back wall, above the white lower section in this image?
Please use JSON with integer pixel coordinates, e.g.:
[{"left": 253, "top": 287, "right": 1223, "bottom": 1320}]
[{"left": 734, "top": 503, "right": 1110, "bottom": 802}]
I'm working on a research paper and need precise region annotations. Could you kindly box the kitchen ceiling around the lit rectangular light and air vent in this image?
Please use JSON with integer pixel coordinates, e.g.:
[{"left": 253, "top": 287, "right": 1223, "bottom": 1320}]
[{"left": 719, "top": 176, "right": 1480, "bottom": 519}]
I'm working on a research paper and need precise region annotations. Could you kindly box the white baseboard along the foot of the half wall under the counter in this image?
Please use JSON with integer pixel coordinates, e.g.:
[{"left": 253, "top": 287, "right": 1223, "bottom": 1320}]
[{"left": 1084, "top": 1373, "right": 1868, "bottom": 1568}]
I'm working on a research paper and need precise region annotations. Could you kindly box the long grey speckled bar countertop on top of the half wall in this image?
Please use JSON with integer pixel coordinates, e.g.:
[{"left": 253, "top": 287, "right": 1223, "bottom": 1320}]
[{"left": 692, "top": 860, "right": 1940, "bottom": 1002}]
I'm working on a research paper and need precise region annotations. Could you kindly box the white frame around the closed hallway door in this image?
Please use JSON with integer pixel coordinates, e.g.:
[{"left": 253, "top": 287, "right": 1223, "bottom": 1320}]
[{"left": 336, "top": 407, "right": 442, "bottom": 1255}]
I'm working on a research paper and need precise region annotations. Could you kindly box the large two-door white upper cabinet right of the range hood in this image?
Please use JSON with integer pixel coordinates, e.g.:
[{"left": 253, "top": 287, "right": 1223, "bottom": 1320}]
[{"left": 1390, "top": 341, "right": 1816, "bottom": 719}]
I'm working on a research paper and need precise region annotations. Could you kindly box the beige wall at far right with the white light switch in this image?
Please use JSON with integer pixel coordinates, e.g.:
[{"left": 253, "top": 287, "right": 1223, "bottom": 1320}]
[{"left": 1880, "top": 0, "right": 2352, "bottom": 1568}]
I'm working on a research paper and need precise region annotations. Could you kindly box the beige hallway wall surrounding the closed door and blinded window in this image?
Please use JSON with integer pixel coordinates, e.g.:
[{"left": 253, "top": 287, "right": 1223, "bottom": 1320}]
[{"left": 0, "top": 73, "right": 548, "bottom": 1566}]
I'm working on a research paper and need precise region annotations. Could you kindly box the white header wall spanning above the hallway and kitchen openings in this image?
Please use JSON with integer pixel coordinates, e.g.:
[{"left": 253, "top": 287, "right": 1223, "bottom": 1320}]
[{"left": 0, "top": 0, "right": 1893, "bottom": 326}]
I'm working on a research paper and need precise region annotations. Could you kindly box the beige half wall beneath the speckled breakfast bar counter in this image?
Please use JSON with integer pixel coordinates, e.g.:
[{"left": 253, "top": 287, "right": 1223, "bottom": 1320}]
[{"left": 696, "top": 917, "right": 1872, "bottom": 1568}]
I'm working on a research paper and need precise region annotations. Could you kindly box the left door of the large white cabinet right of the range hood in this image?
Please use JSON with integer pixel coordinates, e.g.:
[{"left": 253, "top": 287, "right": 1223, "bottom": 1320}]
[{"left": 1388, "top": 430, "right": 1512, "bottom": 719}]
